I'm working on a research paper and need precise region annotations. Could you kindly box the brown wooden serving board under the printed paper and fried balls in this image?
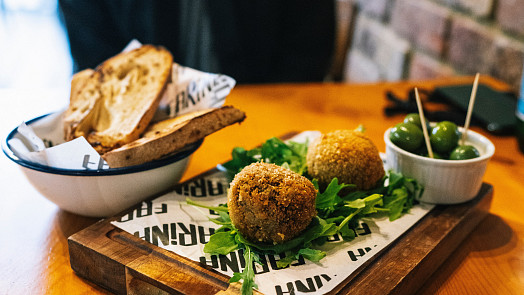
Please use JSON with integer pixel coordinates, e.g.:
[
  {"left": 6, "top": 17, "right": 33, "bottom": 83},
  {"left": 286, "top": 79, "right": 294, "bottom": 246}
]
[{"left": 68, "top": 161, "right": 493, "bottom": 294}]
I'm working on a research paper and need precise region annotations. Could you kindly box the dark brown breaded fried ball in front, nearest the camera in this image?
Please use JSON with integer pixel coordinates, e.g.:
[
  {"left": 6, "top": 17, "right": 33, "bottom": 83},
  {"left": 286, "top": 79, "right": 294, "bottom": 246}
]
[{"left": 227, "top": 163, "right": 317, "bottom": 244}]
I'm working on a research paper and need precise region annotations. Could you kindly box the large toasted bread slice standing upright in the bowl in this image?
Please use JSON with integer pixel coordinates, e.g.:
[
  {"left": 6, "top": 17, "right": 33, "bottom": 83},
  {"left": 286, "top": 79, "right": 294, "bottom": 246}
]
[{"left": 65, "top": 45, "right": 173, "bottom": 154}]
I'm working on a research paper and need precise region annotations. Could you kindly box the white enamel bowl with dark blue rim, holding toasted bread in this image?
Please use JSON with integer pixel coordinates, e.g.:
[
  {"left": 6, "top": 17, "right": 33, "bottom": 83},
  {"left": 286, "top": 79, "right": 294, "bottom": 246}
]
[{"left": 2, "top": 116, "right": 202, "bottom": 217}]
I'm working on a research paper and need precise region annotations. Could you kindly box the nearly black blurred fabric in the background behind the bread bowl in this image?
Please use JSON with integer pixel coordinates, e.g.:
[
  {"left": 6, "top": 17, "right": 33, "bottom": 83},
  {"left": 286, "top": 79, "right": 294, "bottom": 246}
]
[{"left": 59, "top": 0, "right": 335, "bottom": 83}]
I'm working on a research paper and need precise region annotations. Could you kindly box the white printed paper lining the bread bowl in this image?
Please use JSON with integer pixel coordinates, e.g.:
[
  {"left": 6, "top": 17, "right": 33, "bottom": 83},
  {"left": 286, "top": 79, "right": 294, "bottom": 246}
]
[{"left": 8, "top": 40, "right": 236, "bottom": 170}]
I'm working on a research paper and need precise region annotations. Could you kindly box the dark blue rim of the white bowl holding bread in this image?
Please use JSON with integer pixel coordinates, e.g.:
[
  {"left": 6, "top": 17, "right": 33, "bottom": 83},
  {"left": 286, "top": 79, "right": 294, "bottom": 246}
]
[{"left": 2, "top": 114, "right": 204, "bottom": 176}]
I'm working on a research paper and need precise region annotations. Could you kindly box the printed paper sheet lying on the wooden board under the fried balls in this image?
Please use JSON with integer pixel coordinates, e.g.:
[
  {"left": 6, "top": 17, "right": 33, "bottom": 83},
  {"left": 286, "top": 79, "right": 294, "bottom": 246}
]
[{"left": 112, "top": 133, "right": 433, "bottom": 294}]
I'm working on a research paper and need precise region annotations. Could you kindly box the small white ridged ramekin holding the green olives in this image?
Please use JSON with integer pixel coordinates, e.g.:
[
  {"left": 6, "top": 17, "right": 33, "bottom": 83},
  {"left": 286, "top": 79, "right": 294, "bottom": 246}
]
[{"left": 384, "top": 128, "right": 495, "bottom": 204}]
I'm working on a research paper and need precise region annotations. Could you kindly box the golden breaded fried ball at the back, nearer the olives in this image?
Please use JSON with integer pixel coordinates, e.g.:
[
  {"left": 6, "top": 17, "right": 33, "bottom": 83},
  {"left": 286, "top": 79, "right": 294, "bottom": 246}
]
[{"left": 307, "top": 130, "right": 385, "bottom": 190}]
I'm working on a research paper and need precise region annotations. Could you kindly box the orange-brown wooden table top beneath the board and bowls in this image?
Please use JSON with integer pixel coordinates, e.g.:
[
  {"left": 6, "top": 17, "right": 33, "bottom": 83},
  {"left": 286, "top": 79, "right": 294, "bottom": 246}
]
[{"left": 0, "top": 77, "right": 524, "bottom": 294}]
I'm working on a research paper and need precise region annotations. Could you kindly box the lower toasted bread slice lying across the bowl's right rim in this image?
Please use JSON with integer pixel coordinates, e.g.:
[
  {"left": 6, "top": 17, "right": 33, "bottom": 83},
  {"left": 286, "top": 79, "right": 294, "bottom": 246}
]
[{"left": 102, "top": 106, "right": 246, "bottom": 168}]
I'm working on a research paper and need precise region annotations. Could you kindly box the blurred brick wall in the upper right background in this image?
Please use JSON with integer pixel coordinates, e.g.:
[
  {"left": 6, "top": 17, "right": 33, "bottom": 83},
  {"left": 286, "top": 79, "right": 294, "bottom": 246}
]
[{"left": 334, "top": 0, "right": 524, "bottom": 89}]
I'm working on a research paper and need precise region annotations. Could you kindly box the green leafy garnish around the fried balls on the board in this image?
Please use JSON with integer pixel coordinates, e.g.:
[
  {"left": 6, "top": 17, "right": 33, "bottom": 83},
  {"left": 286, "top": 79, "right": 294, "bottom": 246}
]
[{"left": 187, "top": 138, "right": 423, "bottom": 294}]
